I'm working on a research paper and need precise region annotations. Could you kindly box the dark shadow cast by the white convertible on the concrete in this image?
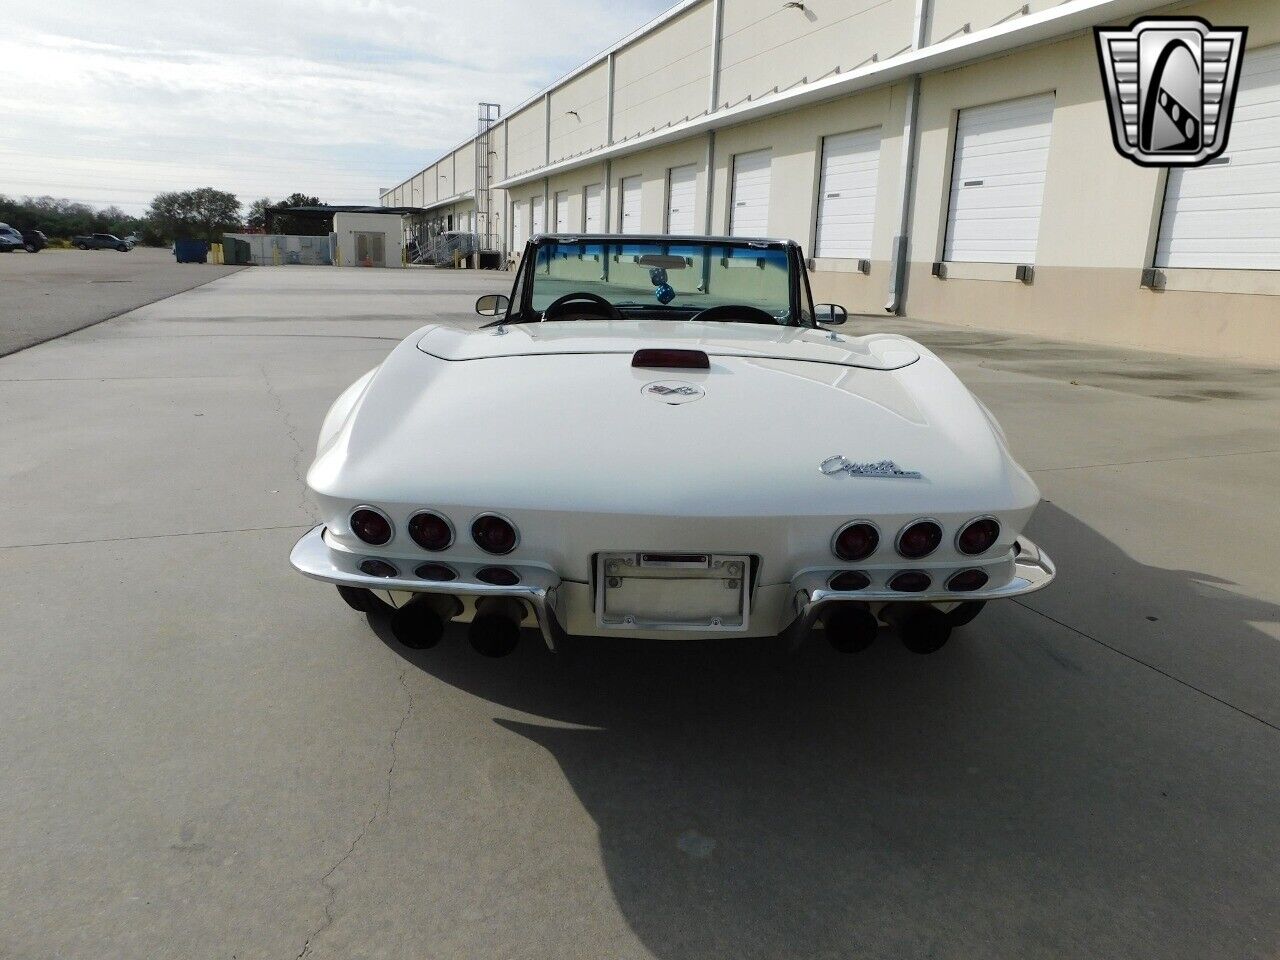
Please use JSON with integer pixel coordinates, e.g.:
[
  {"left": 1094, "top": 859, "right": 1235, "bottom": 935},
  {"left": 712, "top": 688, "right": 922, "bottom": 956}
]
[{"left": 375, "top": 504, "right": 1280, "bottom": 960}]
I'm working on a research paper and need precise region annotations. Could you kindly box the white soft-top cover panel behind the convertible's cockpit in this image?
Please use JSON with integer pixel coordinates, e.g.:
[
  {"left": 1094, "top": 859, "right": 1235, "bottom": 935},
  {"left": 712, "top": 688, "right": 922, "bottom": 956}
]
[{"left": 417, "top": 320, "right": 920, "bottom": 370}]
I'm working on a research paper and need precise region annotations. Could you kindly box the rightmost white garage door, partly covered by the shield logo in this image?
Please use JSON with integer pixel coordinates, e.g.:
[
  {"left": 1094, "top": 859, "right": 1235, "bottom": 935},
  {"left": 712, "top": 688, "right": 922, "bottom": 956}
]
[{"left": 1156, "top": 46, "right": 1280, "bottom": 270}]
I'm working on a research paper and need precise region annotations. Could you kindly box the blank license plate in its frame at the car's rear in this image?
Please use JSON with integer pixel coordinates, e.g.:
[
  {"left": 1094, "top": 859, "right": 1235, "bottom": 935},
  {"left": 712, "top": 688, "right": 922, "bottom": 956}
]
[{"left": 596, "top": 552, "right": 751, "bottom": 632}]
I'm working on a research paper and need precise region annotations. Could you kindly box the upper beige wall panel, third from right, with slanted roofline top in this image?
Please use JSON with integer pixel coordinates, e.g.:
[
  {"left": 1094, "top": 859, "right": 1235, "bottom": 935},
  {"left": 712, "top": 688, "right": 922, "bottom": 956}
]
[{"left": 613, "top": 3, "right": 713, "bottom": 141}]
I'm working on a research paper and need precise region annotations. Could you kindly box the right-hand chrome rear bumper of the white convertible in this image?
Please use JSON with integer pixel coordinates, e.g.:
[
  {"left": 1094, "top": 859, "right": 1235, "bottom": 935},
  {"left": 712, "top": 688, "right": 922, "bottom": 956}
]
[{"left": 783, "top": 537, "right": 1057, "bottom": 644}]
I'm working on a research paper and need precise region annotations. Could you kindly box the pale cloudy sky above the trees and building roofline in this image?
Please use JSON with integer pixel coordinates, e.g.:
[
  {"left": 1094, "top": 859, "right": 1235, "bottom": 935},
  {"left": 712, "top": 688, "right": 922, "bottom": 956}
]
[{"left": 0, "top": 0, "right": 675, "bottom": 214}]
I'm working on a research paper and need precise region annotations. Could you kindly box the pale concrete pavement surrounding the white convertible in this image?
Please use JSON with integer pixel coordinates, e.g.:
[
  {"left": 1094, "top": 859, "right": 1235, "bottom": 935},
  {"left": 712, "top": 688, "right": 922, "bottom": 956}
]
[{"left": 0, "top": 268, "right": 1280, "bottom": 960}]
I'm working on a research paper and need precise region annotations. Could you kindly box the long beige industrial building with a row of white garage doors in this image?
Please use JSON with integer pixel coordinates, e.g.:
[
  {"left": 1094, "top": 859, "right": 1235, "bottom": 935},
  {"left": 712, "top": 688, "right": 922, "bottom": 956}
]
[{"left": 380, "top": 0, "right": 1280, "bottom": 364}]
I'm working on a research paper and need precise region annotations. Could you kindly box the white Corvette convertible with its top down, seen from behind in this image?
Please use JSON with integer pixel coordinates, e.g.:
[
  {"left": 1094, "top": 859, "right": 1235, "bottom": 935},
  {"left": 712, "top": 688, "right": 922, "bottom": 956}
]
[{"left": 292, "top": 236, "right": 1055, "bottom": 655}]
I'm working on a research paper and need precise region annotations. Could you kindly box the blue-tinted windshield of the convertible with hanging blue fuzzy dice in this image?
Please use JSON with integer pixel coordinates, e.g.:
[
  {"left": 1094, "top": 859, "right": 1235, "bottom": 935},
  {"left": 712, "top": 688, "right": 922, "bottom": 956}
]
[{"left": 531, "top": 239, "right": 801, "bottom": 325}]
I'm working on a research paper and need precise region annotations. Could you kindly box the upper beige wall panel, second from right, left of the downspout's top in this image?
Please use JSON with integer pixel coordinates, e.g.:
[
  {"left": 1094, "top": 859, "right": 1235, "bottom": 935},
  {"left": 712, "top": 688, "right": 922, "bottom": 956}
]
[{"left": 718, "top": 0, "right": 916, "bottom": 106}]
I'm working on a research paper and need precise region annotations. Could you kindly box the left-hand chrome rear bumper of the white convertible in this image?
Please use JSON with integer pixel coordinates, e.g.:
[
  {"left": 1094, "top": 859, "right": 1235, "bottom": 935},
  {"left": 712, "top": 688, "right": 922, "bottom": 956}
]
[{"left": 289, "top": 524, "right": 564, "bottom": 650}]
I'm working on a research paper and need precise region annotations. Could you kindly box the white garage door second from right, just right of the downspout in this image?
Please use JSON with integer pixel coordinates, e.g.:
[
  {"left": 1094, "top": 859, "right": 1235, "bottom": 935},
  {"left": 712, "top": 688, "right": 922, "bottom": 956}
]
[{"left": 942, "top": 93, "right": 1053, "bottom": 264}]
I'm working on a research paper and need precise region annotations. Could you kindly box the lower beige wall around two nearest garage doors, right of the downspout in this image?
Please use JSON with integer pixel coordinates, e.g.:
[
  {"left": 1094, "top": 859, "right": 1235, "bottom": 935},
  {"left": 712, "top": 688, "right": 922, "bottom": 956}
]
[{"left": 901, "top": 0, "right": 1280, "bottom": 364}]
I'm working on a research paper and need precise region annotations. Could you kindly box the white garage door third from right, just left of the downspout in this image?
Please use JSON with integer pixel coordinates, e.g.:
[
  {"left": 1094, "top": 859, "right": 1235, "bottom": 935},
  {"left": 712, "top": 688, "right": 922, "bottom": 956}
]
[{"left": 814, "top": 127, "right": 879, "bottom": 260}]
